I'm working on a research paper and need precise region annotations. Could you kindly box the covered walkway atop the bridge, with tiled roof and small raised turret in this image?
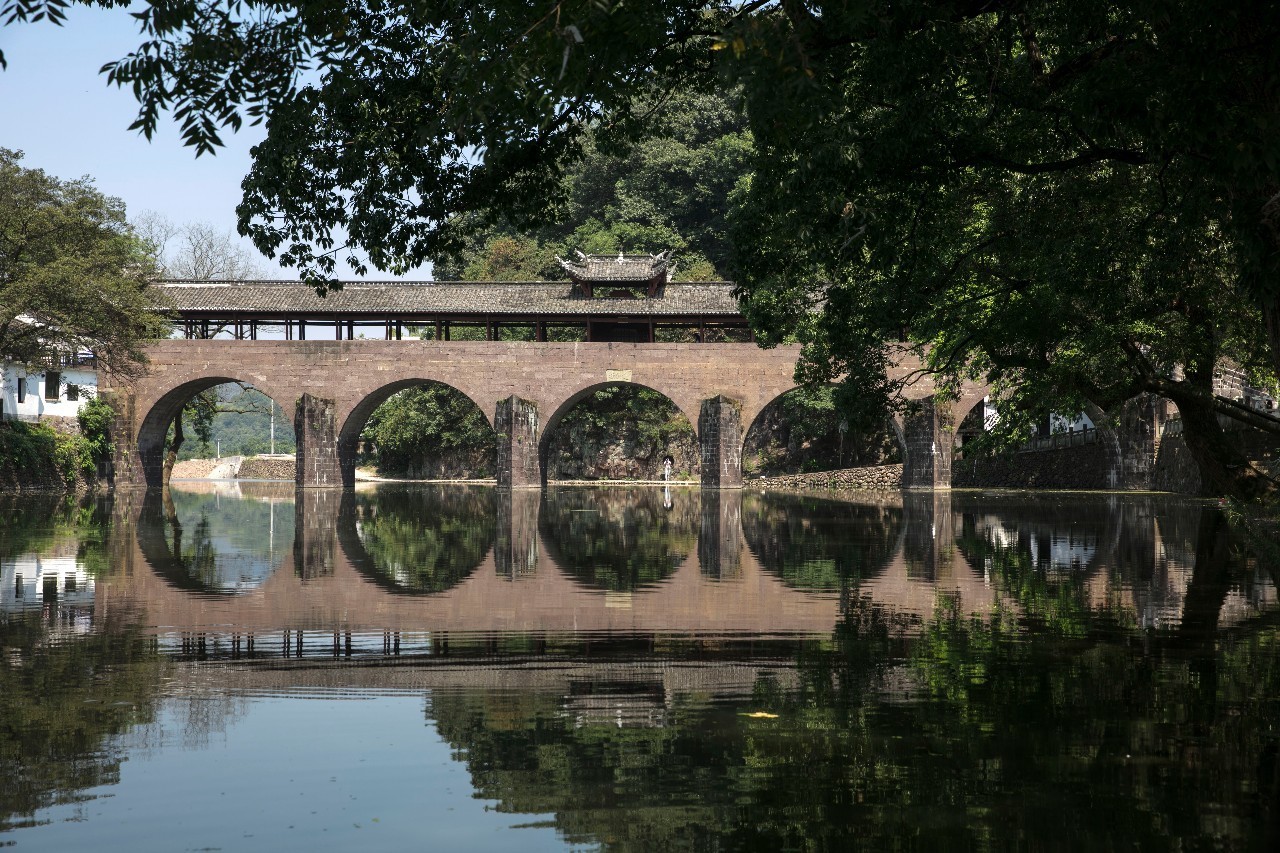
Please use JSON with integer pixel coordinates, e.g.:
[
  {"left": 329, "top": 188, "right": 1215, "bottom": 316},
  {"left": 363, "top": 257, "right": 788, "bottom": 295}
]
[{"left": 155, "top": 252, "right": 751, "bottom": 343}]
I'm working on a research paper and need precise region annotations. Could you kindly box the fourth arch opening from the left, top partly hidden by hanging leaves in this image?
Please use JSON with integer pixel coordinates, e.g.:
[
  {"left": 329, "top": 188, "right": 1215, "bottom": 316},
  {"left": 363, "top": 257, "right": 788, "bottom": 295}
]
[{"left": 742, "top": 386, "right": 902, "bottom": 476}]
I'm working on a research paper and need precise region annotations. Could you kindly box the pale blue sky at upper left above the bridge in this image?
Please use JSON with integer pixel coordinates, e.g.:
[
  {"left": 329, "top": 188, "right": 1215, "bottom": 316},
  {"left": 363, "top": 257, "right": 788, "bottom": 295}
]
[{"left": 0, "top": 6, "right": 429, "bottom": 278}]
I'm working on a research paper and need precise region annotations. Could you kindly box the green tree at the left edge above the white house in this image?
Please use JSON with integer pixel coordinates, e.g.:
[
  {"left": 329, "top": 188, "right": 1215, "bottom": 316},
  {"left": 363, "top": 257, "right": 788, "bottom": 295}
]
[{"left": 0, "top": 149, "right": 168, "bottom": 375}]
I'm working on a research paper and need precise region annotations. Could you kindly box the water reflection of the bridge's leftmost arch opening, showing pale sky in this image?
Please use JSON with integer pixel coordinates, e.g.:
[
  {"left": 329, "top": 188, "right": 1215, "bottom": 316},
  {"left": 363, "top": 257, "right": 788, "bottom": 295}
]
[{"left": 137, "top": 488, "right": 294, "bottom": 596}]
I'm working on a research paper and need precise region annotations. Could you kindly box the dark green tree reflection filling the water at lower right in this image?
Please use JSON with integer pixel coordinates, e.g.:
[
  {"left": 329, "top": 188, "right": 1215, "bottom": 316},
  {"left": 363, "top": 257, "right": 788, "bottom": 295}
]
[{"left": 428, "top": 502, "right": 1280, "bottom": 850}]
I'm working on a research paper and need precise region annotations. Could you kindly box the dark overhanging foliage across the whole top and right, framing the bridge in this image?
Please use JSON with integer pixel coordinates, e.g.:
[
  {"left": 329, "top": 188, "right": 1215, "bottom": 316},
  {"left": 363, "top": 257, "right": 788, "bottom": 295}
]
[{"left": 5, "top": 0, "right": 1280, "bottom": 491}]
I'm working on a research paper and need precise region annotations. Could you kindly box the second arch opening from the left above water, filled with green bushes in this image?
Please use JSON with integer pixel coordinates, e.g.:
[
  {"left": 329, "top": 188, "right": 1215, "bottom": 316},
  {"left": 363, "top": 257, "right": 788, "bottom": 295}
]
[{"left": 338, "top": 379, "right": 498, "bottom": 484}]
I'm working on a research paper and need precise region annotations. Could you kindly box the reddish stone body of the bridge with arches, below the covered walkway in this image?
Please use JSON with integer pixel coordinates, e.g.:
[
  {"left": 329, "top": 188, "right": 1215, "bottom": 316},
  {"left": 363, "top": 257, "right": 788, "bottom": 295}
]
[{"left": 102, "top": 338, "right": 987, "bottom": 488}]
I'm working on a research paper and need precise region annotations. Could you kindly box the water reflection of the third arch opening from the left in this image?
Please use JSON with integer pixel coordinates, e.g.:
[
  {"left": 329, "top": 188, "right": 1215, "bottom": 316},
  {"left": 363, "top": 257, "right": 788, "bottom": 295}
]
[{"left": 539, "top": 488, "right": 701, "bottom": 592}]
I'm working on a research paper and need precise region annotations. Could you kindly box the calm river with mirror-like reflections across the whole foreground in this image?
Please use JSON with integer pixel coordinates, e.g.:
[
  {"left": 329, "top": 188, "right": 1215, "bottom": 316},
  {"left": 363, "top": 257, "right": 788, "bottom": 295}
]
[{"left": 0, "top": 483, "right": 1280, "bottom": 853}]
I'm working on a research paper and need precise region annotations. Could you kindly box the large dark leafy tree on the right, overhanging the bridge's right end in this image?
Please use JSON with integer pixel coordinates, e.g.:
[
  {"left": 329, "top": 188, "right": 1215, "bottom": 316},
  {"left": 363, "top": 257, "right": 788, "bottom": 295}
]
[{"left": 735, "top": 3, "right": 1280, "bottom": 493}]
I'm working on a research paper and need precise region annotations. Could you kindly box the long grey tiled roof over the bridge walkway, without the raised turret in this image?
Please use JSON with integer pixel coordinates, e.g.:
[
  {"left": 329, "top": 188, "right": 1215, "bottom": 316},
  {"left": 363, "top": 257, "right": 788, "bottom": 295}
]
[{"left": 156, "top": 282, "right": 741, "bottom": 318}]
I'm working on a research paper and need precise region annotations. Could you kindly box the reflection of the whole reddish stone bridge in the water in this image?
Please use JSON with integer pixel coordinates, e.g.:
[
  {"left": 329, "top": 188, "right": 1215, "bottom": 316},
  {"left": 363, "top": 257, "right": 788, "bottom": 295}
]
[{"left": 95, "top": 484, "right": 1274, "bottom": 657}]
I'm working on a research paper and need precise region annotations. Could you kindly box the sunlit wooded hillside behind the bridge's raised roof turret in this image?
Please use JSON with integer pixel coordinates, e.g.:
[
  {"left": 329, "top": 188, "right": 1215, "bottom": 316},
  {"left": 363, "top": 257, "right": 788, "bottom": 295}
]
[{"left": 433, "top": 88, "right": 751, "bottom": 280}]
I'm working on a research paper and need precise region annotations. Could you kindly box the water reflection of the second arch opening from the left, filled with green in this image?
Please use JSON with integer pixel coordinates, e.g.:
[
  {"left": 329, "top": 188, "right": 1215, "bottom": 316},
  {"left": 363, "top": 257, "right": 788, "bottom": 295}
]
[{"left": 338, "top": 485, "right": 497, "bottom": 596}]
